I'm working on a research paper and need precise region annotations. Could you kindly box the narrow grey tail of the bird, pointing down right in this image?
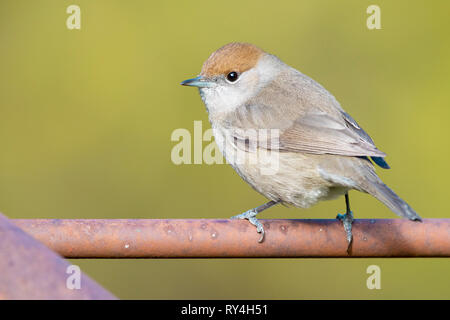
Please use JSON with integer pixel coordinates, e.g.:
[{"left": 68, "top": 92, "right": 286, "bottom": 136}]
[{"left": 365, "top": 176, "right": 422, "bottom": 221}]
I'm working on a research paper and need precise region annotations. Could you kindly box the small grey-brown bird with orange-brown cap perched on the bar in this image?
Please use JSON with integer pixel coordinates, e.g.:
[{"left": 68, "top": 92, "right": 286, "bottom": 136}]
[{"left": 181, "top": 42, "right": 421, "bottom": 250}]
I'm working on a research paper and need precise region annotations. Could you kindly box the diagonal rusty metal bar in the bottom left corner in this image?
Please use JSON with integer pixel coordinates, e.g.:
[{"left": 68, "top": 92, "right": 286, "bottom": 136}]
[{"left": 0, "top": 214, "right": 116, "bottom": 300}]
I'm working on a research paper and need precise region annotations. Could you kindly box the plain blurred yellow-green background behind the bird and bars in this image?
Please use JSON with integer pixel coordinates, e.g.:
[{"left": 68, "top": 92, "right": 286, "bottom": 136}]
[{"left": 0, "top": 0, "right": 450, "bottom": 299}]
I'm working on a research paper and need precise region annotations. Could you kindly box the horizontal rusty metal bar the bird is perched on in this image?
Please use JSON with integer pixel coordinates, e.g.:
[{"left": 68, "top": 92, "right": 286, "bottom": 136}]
[{"left": 13, "top": 219, "right": 450, "bottom": 258}]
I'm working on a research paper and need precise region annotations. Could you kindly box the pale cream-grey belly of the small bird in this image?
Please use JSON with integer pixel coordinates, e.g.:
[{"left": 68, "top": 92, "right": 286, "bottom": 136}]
[{"left": 216, "top": 126, "right": 349, "bottom": 208}]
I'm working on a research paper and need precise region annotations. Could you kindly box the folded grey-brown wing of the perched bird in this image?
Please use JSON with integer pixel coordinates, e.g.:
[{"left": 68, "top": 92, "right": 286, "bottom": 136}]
[{"left": 226, "top": 69, "right": 386, "bottom": 157}]
